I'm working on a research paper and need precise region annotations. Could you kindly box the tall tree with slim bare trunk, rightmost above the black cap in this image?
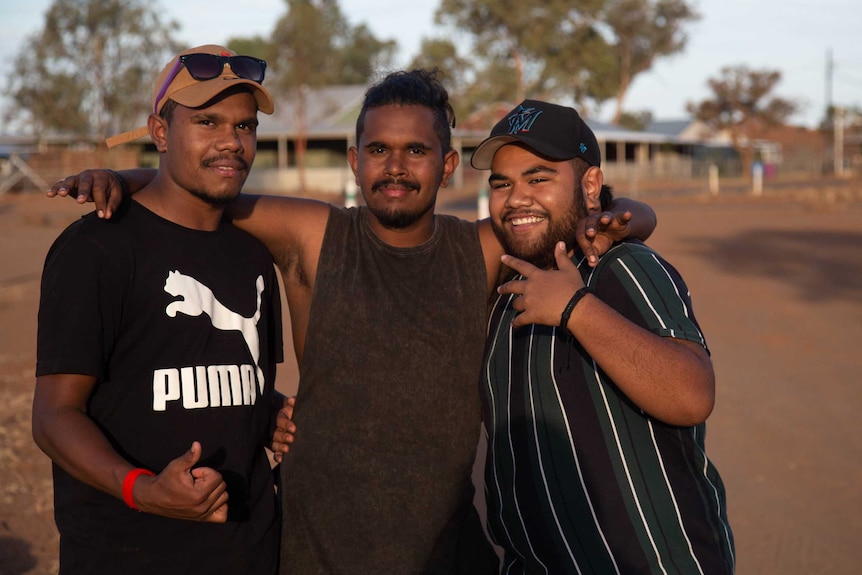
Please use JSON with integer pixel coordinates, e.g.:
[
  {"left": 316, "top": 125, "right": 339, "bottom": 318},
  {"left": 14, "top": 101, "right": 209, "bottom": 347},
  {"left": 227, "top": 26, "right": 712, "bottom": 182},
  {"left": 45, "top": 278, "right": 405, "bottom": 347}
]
[{"left": 601, "top": 0, "right": 700, "bottom": 124}]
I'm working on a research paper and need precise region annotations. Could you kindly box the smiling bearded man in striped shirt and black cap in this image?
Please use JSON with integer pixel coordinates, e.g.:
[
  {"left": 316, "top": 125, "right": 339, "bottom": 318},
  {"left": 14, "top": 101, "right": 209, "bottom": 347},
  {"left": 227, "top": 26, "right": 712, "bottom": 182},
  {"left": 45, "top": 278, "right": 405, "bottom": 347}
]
[{"left": 472, "top": 100, "right": 734, "bottom": 575}]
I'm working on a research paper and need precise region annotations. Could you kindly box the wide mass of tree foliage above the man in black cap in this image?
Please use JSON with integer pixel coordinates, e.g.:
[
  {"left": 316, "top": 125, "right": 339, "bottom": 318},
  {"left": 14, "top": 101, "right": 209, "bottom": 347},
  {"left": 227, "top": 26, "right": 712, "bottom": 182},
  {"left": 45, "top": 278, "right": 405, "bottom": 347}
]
[{"left": 435, "top": 0, "right": 697, "bottom": 125}]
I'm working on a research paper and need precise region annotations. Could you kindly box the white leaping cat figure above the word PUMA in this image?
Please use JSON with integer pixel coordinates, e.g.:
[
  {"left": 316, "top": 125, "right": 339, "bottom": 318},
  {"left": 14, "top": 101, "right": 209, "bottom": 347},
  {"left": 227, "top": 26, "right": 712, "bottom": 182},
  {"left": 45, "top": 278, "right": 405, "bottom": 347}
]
[{"left": 165, "top": 271, "right": 264, "bottom": 393}]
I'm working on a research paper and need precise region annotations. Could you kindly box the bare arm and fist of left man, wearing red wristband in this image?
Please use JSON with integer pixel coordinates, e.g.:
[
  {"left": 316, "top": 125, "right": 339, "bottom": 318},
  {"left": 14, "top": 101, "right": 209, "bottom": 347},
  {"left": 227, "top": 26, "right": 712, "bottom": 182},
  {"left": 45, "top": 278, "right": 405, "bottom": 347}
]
[{"left": 33, "top": 374, "right": 228, "bottom": 523}]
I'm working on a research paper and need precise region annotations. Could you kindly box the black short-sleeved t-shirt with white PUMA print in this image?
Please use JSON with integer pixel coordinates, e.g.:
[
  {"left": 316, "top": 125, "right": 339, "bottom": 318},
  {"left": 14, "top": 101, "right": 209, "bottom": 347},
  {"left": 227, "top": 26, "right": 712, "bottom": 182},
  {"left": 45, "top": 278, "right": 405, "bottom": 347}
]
[{"left": 37, "top": 200, "right": 282, "bottom": 575}]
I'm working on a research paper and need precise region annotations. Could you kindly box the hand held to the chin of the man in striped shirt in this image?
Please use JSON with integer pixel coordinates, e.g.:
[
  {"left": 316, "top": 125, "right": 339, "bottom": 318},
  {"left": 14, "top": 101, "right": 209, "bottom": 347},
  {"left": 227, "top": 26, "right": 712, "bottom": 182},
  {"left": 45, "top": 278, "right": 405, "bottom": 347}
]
[{"left": 497, "top": 242, "right": 584, "bottom": 327}]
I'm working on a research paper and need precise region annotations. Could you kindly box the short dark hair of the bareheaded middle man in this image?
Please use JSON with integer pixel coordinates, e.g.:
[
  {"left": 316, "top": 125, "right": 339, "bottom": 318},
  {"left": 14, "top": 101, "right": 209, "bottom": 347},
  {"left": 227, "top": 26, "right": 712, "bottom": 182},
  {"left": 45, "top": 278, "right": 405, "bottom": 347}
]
[{"left": 356, "top": 68, "right": 455, "bottom": 154}]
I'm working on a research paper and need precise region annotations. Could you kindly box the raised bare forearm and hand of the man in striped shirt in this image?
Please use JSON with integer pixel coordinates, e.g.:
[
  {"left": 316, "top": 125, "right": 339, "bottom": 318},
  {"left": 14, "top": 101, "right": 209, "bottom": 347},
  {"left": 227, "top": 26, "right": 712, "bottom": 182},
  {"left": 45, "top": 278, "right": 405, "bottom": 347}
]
[{"left": 499, "top": 244, "right": 715, "bottom": 425}]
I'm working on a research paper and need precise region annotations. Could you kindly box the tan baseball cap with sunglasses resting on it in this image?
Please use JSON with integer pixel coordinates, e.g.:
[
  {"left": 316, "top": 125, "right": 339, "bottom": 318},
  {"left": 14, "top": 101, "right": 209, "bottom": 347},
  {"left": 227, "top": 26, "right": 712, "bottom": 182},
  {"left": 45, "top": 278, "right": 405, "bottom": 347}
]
[{"left": 105, "top": 44, "right": 275, "bottom": 148}]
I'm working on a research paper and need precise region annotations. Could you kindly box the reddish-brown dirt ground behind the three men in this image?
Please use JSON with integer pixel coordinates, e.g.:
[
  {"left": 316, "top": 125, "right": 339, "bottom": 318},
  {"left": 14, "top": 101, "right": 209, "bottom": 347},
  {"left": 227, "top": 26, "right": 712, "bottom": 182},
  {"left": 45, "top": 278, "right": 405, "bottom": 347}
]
[{"left": 0, "top": 180, "right": 862, "bottom": 575}]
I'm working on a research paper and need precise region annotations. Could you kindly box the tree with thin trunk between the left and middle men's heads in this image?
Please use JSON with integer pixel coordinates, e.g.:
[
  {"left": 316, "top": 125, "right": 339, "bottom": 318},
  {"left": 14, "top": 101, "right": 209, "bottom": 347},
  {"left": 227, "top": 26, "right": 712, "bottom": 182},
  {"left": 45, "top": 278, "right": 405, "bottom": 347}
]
[{"left": 271, "top": 0, "right": 396, "bottom": 191}]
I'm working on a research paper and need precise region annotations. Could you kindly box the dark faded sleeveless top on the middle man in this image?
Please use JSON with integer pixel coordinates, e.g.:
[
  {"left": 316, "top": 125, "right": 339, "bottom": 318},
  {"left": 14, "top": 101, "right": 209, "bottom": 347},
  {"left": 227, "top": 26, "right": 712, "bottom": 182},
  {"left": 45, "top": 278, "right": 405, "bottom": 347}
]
[{"left": 281, "top": 207, "right": 487, "bottom": 575}]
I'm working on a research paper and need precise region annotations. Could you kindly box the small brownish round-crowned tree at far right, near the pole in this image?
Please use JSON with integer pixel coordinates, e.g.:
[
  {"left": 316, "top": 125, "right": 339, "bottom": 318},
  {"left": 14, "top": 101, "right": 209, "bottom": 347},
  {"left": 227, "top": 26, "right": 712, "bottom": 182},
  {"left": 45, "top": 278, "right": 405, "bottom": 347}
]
[{"left": 686, "top": 65, "right": 799, "bottom": 177}]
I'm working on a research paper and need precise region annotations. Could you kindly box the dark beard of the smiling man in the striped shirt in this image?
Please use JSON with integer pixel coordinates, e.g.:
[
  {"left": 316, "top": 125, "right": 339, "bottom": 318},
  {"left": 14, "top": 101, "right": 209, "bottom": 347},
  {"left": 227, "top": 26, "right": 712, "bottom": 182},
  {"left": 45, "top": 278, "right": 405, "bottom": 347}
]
[{"left": 491, "top": 186, "right": 587, "bottom": 269}]
